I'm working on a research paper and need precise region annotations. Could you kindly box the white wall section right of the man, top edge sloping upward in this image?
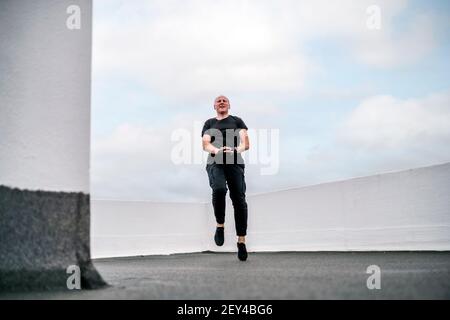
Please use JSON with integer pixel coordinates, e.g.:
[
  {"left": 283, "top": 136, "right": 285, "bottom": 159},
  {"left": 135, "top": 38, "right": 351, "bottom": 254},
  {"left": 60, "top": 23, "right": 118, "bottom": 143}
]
[{"left": 249, "top": 163, "right": 450, "bottom": 251}]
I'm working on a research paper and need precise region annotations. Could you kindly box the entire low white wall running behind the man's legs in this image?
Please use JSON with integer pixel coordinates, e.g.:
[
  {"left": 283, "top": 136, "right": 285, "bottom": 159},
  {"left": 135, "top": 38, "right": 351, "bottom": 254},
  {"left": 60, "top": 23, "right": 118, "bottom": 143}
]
[{"left": 91, "top": 163, "right": 450, "bottom": 257}]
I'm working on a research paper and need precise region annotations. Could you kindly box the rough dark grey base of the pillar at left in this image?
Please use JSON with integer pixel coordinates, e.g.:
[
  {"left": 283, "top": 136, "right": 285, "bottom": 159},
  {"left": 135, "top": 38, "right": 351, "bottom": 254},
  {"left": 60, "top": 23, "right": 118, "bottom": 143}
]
[{"left": 0, "top": 186, "right": 104, "bottom": 291}]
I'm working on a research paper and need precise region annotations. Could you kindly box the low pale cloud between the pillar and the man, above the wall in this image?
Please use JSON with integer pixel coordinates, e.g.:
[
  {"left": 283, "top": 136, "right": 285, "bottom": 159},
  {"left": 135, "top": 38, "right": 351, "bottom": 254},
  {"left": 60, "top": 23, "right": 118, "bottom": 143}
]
[{"left": 91, "top": 115, "right": 209, "bottom": 201}]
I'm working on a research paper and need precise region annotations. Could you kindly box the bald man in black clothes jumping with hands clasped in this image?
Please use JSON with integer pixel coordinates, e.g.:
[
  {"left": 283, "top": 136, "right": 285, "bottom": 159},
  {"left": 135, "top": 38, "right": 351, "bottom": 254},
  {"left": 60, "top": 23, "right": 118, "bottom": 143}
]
[{"left": 202, "top": 96, "right": 250, "bottom": 261}]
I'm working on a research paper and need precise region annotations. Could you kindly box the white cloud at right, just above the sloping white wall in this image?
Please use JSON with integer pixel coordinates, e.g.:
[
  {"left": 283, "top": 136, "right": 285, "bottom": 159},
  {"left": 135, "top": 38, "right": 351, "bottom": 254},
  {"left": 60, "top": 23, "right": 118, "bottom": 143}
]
[{"left": 271, "top": 91, "right": 450, "bottom": 186}]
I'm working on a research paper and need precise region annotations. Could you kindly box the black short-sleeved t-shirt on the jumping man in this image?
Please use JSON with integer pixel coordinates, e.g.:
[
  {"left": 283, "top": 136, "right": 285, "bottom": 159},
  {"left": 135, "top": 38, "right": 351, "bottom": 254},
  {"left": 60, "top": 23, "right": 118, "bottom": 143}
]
[{"left": 202, "top": 115, "right": 248, "bottom": 164}]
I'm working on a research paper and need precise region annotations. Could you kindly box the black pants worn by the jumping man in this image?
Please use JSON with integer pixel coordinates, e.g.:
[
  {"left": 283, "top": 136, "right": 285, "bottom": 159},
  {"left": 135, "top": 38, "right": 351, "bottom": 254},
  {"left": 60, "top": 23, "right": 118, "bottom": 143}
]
[{"left": 206, "top": 163, "right": 248, "bottom": 236}]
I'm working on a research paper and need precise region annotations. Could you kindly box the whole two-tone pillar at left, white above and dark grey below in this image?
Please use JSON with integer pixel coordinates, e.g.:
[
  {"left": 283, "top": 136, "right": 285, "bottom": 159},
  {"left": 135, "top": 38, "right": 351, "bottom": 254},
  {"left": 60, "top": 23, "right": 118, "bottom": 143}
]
[{"left": 0, "top": 0, "right": 105, "bottom": 290}]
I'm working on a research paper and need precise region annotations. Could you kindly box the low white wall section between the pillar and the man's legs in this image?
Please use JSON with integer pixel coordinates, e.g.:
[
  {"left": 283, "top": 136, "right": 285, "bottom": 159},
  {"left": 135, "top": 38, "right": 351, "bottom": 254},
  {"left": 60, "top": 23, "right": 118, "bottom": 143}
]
[{"left": 91, "top": 200, "right": 208, "bottom": 258}]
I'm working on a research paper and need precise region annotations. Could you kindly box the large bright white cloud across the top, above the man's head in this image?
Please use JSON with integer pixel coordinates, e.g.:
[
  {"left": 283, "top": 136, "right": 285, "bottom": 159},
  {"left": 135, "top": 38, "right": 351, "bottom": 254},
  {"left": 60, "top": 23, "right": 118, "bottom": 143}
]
[{"left": 93, "top": 0, "right": 433, "bottom": 101}]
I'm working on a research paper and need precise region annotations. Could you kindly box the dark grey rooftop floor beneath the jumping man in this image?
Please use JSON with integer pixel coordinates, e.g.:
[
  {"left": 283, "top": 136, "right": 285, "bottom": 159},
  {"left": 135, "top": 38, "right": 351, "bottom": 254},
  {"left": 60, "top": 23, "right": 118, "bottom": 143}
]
[{"left": 0, "top": 252, "right": 450, "bottom": 300}]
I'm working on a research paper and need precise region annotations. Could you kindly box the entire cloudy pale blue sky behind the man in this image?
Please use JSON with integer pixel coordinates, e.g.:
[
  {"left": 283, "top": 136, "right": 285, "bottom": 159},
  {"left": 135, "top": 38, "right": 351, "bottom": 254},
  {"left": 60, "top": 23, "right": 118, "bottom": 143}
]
[{"left": 91, "top": 0, "right": 450, "bottom": 202}]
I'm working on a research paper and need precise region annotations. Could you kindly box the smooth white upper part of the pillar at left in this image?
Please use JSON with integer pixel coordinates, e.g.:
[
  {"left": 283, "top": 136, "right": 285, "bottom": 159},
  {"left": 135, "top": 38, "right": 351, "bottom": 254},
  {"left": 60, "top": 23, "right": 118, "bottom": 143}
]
[{"left": 0, "top": 0, "right": 92, "bottom": 193}]
